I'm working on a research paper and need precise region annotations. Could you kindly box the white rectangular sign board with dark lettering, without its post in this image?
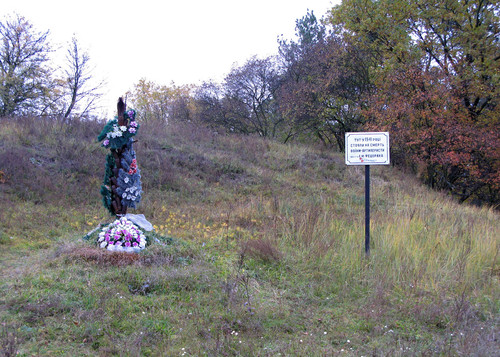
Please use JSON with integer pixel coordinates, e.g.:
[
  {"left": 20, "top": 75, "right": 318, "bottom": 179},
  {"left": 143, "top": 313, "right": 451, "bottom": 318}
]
[{"left": 345, "top": 132, "right": 390, "bottom": 165}]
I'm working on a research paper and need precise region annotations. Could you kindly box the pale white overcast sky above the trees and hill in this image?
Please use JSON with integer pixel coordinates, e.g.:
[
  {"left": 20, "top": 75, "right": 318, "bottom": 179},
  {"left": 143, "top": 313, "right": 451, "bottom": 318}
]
[{"left": 0, "top": 0, "right": 340, "bottom": 112}]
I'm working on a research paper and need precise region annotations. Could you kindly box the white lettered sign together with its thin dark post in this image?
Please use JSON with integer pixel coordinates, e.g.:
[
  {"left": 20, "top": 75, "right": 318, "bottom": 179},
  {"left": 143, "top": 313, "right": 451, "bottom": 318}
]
[{"left": 345, "top": 132, "right": 390, "bottom": 256}]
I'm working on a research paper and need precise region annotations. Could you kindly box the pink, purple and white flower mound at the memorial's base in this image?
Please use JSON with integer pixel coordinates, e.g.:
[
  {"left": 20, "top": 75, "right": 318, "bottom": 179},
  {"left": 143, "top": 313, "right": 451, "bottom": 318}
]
[{"left": 97, "top": 217, "right": 147, "bottom": 252}]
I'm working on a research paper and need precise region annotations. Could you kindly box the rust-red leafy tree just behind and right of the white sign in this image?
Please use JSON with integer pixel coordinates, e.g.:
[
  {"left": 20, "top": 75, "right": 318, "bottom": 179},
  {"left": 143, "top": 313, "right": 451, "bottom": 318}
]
[{"left": 365, "top": 65, "right": 500, "bottom": 203}]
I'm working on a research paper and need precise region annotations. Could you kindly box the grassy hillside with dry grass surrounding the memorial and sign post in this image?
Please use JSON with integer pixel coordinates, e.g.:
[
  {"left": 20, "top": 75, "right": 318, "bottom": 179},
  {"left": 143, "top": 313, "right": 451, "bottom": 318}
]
[{"left": 0, "top": 118, "right": 500, "bottom": 356}]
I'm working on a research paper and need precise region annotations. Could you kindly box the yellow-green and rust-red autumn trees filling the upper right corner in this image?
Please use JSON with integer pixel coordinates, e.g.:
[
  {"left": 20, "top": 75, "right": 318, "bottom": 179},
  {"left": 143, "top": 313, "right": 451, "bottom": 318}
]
[{"left": 330, "top": 0, "right": 500, "bottom": 205}]
